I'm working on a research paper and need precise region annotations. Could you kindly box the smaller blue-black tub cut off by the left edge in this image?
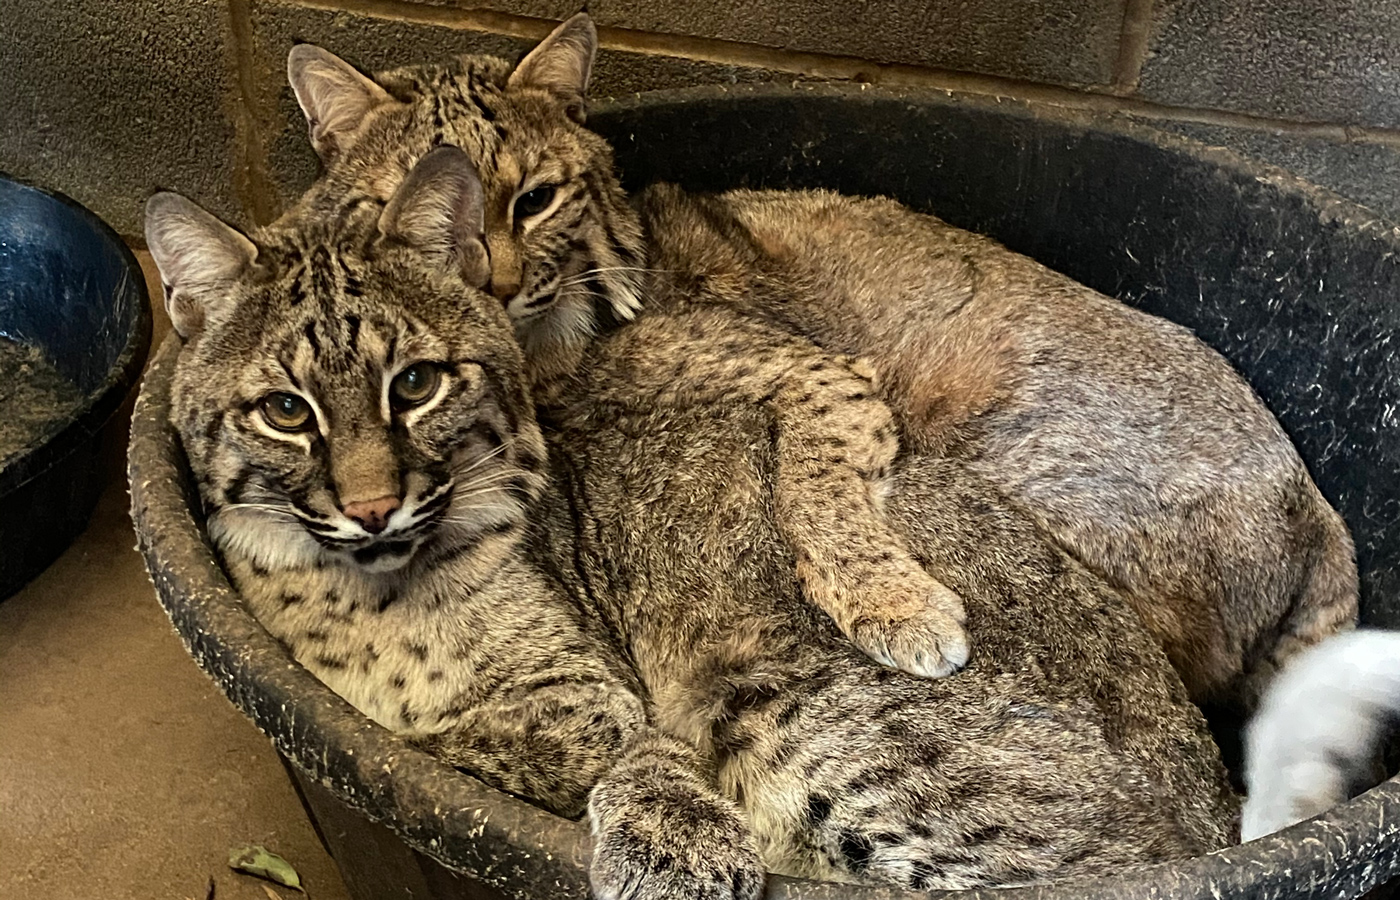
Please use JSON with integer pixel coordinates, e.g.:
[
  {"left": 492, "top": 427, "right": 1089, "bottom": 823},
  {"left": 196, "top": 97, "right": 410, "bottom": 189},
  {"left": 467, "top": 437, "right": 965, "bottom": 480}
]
[{"left": 0, "top": 175, "right": 151, "bottom": 599}]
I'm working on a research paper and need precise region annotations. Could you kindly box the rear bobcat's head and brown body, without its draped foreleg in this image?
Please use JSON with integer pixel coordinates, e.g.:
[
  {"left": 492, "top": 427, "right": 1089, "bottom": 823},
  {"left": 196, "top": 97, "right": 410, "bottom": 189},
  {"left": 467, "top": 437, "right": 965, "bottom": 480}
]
[{"left": 288, "top": 14, "right": 1357, "bottom": 707}]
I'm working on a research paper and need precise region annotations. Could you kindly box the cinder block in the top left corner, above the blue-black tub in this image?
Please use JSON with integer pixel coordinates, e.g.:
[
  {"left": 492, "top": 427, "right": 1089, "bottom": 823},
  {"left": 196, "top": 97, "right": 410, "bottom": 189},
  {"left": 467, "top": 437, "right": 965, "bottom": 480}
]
[{"left": 0, "top": 0, "right": 241, "bottom": 235}]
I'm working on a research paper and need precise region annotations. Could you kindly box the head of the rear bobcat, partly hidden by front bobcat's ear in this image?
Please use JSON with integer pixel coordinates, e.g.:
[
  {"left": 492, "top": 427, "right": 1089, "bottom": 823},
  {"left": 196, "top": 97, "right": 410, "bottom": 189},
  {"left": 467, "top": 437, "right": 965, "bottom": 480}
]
[{"left": 288, "top": 20, "right": 644, "bottom": 354}]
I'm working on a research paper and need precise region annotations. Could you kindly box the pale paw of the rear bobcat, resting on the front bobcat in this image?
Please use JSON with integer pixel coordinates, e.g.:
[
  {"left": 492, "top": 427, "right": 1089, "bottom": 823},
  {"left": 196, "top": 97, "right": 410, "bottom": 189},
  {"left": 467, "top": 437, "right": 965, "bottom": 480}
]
[{"left": 851, "top": 582, "right": 972, "bottom": 677}]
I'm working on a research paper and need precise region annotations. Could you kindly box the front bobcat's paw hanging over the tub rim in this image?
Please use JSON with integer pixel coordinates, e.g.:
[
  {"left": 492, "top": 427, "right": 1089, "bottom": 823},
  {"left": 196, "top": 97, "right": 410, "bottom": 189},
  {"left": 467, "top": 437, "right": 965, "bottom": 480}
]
[{"left": 588, "top": 777, "right": 764, "bottom": 900}]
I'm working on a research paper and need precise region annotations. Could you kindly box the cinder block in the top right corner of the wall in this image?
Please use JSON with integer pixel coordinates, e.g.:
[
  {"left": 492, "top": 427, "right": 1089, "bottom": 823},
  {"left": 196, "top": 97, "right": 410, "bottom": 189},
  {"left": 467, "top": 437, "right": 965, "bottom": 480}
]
[{"left": 1140, "top": 0, "right": 1400, "bottom": 127}]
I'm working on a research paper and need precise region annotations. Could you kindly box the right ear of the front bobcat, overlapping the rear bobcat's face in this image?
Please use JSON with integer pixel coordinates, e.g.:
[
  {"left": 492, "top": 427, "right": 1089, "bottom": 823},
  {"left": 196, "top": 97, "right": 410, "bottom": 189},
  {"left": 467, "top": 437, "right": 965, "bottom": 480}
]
[{"left": 379, "top": 147, "right": 491, "bottom": 287}]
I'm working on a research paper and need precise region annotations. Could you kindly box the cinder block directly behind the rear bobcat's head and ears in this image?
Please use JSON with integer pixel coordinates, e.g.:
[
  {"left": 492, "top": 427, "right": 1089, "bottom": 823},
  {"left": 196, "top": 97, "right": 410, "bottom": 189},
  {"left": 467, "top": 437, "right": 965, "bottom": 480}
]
[{"left": 253, "top": 1, "right": 791, "bottom": 210}]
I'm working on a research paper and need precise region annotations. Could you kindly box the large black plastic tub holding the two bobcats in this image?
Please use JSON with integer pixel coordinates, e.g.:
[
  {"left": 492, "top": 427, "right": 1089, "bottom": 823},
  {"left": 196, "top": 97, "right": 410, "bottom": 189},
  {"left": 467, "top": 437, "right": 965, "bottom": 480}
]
[{"left": 130, "top": 85, "right": 1400, "bottom": 900}]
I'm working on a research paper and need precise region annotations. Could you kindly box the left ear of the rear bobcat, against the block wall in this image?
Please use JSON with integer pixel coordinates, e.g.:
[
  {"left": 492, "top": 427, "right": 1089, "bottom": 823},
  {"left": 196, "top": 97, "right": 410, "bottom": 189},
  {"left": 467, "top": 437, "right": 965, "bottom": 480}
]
[{"left": 287, "top": 43, "right": 393, "bottom": 165}]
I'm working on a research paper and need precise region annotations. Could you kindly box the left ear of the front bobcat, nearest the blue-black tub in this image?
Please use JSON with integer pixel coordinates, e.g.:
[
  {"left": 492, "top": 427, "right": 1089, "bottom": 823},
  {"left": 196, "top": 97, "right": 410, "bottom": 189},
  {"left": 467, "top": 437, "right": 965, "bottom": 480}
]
[{"left": 146, "top": 193, "right": 258, "bottom": 340}]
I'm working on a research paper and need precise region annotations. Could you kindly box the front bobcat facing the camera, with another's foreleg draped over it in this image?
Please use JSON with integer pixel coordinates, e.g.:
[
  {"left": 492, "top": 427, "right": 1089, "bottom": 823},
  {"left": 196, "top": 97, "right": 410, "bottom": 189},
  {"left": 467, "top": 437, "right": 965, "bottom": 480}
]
[{"left": 147, "top": 147, "right": 1236, "bottom": 900}]
